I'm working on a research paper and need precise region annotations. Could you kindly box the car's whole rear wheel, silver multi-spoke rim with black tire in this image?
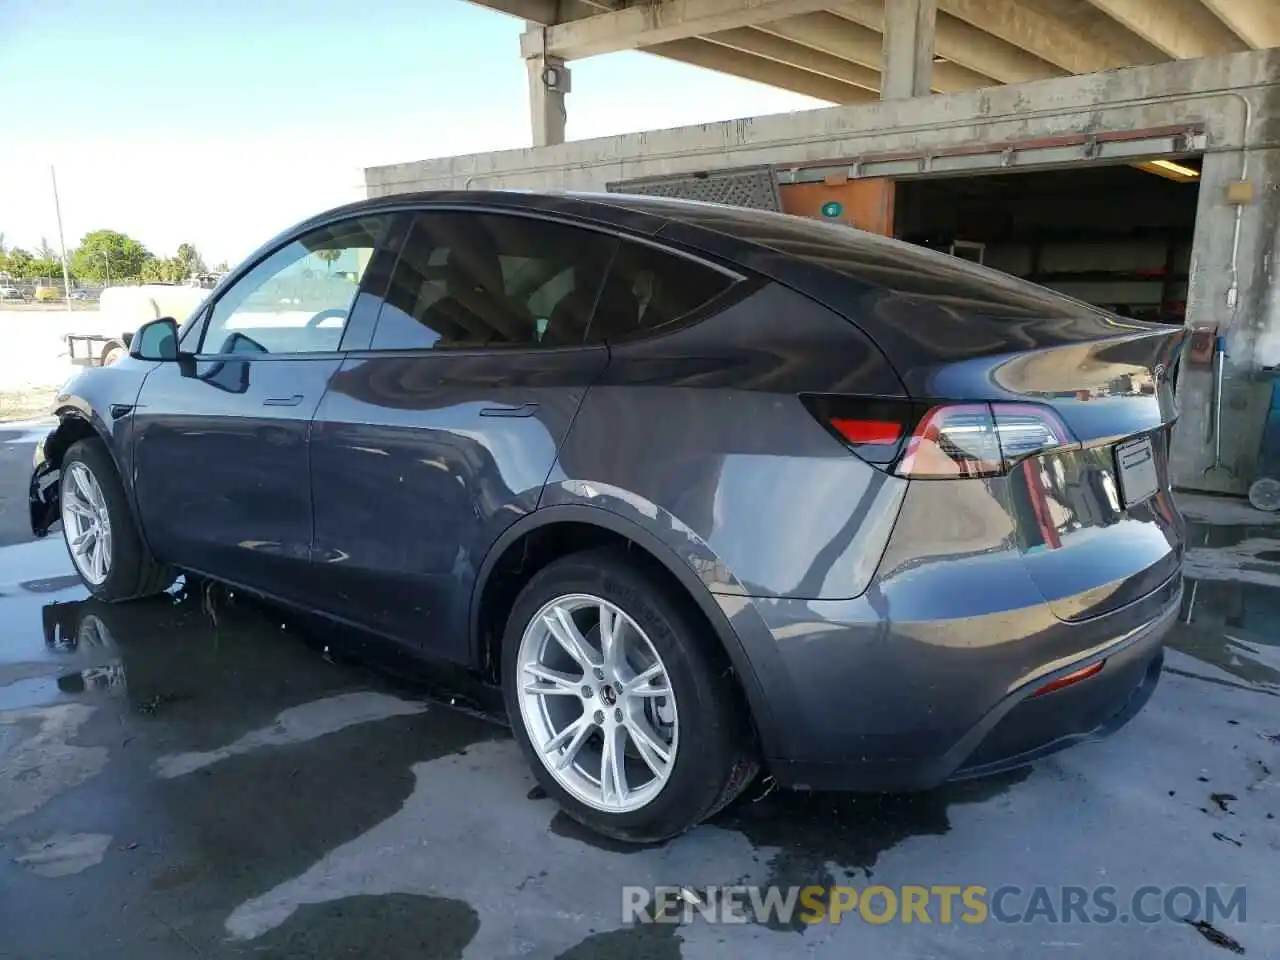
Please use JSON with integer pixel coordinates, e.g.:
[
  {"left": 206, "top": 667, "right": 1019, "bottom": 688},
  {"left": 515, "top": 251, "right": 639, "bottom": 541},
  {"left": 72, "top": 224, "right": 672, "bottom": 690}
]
[{"left": 503, "top": 549, "right": 756, "bottom": 842}]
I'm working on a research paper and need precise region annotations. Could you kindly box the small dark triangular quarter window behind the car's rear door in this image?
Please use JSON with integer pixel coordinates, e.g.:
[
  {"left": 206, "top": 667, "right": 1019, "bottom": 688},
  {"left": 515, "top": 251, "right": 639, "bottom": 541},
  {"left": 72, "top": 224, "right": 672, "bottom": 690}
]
[{"left": 588, "top": 241, "right": 736, "bottom": 343}]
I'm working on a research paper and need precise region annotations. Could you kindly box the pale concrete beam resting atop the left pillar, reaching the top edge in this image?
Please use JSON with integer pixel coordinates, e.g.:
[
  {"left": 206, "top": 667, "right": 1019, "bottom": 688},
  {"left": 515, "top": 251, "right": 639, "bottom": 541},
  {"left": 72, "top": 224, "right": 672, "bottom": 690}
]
[{"left": 520, "top": 0, "right": 831, "bottom": 60}]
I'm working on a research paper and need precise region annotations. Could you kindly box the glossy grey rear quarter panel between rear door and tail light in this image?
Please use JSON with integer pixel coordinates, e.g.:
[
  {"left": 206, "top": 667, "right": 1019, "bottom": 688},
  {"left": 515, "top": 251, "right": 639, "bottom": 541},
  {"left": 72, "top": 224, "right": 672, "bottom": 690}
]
[{"left": 543, "top": 285, "right": 906, "bottom": 598}]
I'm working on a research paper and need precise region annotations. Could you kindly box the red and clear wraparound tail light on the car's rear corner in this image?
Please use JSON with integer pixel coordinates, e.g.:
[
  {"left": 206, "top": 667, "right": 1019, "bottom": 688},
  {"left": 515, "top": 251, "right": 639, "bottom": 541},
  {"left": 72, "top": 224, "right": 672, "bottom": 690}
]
[{"left": 801, "top": 396, "right": 1075, "bottom": 480}]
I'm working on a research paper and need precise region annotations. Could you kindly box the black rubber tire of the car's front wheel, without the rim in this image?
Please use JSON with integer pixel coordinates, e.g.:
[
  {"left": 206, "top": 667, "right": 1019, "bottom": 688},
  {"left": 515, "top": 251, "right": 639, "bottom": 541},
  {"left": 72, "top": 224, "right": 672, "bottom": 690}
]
[{"left": 59, "top": 438, "right": 177, "bottom": 603}]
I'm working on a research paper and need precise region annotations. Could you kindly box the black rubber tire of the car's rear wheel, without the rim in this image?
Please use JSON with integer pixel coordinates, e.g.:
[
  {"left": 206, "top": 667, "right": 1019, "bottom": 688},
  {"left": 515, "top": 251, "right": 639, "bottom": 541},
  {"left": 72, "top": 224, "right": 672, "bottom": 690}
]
[{"left": 502, "top": 548, "right": 759, "bottom": 844}]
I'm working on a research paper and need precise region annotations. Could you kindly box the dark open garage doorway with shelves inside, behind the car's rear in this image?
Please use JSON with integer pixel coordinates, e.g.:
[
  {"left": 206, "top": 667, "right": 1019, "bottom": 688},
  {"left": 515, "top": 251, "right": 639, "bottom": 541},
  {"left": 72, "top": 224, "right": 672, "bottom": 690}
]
[{"left": 893, "top": 157, "right": 1201, "bottom": 324}]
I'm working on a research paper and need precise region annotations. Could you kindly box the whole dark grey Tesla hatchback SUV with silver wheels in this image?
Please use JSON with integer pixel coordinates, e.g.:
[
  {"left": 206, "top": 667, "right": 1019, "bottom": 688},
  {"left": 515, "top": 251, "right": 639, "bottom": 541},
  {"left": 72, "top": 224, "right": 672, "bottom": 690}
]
[{"left": 31, "top": 192, "right": 1184, "bottom": 841}]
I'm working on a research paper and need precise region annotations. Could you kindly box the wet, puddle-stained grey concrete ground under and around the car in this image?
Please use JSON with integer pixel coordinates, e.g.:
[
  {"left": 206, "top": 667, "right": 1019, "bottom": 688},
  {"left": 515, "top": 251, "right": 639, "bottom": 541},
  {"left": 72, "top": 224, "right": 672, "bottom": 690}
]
[{"left": 0, "top": 417, "right": 1280, "bottom": 960}]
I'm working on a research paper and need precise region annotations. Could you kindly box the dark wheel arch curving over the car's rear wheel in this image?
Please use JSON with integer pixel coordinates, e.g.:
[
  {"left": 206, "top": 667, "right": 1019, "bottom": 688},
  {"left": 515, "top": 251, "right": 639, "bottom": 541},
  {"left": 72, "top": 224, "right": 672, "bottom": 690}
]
[{"left": 468, "top": 504, "right": 773, "bottom": 755}]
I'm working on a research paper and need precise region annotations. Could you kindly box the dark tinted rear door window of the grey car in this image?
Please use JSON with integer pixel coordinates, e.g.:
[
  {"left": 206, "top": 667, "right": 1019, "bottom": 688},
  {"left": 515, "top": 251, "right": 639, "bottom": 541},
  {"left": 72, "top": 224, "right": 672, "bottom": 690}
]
[{"left": 372, "top": 212, "right": 616, "bottom": 349}]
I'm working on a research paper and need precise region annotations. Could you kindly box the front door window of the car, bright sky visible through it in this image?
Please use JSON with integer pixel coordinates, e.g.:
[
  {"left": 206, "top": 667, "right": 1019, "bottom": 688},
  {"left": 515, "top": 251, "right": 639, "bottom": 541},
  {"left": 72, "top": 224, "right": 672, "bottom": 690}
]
[{"left": 201, "top": 216, "right": 387, "bottom": 353}]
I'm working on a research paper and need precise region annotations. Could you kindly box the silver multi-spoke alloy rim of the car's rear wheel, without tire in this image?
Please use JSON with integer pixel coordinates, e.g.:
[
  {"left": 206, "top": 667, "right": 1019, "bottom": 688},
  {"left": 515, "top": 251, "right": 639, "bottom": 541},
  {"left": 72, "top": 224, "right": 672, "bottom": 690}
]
[{"left": 516, "top": 594, "right": 680, "bottom": 813}]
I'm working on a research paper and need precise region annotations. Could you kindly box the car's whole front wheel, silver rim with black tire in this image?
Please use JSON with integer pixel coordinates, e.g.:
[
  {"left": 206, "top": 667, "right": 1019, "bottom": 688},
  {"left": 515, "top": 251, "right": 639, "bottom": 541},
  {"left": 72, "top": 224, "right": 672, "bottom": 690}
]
[{"left": 59, "top": 439, "right": 174, "bottom": 600}]
